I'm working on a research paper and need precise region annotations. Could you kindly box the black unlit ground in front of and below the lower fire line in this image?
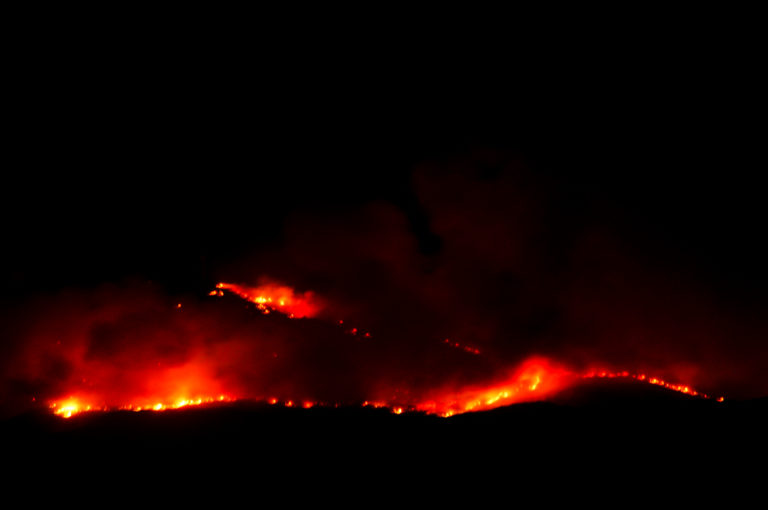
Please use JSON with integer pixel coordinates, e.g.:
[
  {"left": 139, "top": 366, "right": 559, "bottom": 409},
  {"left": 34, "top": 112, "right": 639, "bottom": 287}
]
[{"left": 2, "top": 383, "right": 768, "bottom": 497}]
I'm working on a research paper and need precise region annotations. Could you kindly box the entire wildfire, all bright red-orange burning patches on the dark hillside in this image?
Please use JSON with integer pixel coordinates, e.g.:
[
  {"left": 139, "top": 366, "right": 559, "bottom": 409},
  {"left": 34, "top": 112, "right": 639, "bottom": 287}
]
[{"left": 42, "top": 283, "right": 724, "bottom": 418}]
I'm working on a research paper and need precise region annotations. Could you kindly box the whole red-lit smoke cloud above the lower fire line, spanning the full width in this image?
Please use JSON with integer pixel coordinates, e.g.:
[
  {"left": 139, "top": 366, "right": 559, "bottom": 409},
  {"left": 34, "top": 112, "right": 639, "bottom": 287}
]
[{"left": 0, "top": 150, "right": 768, "bottom": 414}]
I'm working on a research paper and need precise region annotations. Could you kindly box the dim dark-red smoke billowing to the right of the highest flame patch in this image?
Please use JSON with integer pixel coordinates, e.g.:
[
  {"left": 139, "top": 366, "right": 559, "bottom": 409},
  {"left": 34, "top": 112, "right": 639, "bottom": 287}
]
[{"left": 213, "top": 154, "right": 768, "bottom": 397}]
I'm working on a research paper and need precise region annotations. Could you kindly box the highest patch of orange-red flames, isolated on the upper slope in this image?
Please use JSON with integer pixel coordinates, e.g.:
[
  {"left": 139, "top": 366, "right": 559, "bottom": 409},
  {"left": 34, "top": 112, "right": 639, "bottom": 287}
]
[{"left": 211, "top": 283, "right": 321, "bottom": 319}]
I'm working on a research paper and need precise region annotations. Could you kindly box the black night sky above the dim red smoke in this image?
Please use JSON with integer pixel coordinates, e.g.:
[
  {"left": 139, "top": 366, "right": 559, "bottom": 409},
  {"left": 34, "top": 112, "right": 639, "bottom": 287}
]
[{"left": 3, "top": 46, "right": 766, "bottom": 295}]
